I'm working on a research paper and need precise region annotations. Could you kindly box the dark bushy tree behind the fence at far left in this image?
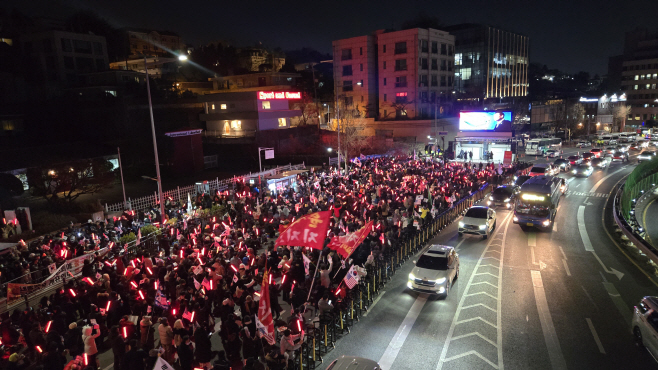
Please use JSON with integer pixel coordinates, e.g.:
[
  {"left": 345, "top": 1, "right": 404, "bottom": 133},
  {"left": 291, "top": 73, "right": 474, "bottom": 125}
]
[{"left": 27, "top": 159, "right": 114, "bottom": 207}]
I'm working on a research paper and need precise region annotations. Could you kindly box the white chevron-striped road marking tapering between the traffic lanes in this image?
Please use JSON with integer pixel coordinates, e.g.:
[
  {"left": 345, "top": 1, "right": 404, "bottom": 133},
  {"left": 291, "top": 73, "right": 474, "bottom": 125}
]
[{"left": 436, "top": 213, "right": 512, "bottom": 370}]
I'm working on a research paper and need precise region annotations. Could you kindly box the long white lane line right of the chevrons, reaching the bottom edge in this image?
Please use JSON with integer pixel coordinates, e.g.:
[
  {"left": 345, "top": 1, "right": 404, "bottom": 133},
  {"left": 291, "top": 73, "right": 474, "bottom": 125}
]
[{"left": 530, "top": 270, "right": 567, "bottom": 370}]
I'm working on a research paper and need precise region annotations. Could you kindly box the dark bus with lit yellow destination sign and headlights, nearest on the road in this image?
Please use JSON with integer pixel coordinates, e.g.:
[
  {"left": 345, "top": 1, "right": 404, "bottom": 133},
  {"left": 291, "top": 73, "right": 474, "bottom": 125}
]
[{"left": 512, "top": 176, "right": 562, "bottom": 231}]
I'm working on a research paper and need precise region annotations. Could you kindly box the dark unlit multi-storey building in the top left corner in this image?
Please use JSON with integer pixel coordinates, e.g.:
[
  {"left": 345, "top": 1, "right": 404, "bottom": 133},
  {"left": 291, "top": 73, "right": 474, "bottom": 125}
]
[{"left": 20, "top": 30, "right": 109, "bottom": 86}]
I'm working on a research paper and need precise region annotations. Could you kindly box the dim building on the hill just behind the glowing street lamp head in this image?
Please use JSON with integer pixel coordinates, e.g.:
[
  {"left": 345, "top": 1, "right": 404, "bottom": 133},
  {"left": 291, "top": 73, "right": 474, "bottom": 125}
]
[{"left": 125, "top": 29, "right": 186, "bottom": 59}]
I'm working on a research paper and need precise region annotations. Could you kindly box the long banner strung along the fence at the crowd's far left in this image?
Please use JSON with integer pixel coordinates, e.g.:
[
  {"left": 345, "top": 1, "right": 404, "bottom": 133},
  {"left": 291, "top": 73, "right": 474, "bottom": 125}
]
[{"left": 7, "top": 248, "right": 109, "bottom": 306}]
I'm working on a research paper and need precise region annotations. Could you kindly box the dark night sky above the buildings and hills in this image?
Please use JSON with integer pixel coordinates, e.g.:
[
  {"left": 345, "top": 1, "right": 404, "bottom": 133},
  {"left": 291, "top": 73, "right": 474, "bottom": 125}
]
[{"left": 5, "top": 0, "right": 658, "bottom": 75}]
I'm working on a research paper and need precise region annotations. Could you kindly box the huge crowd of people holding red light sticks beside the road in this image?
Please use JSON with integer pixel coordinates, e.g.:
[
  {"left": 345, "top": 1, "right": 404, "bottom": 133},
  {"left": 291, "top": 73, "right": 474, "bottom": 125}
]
[{"left": 0, "top": 157, "right": 525, "bottom": 370}]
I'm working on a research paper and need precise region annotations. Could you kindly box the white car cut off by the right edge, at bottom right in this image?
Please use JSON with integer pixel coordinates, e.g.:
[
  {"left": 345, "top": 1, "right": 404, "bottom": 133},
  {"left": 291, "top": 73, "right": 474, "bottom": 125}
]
[{"left": 632, "top": 297, "right": 658, "bottom": 358}]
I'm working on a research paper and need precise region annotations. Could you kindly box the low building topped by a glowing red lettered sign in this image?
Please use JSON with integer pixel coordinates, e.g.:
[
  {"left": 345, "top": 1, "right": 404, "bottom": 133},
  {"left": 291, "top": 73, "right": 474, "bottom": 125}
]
[{"left": 198, "top": 91, "right": 301, "bottom": 138}]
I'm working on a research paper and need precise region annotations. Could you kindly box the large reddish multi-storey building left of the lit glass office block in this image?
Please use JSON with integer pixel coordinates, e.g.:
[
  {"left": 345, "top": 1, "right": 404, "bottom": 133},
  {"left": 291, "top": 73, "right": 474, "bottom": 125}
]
[{"left": 333, "top": 28, "right": 454, "bottom": 120}]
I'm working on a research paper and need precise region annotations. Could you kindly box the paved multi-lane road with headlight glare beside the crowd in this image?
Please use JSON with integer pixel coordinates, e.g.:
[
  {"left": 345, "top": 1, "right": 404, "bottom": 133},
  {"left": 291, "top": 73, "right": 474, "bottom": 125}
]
[{"left": 323, "top": 149, "right": 658, "bottom": 370}]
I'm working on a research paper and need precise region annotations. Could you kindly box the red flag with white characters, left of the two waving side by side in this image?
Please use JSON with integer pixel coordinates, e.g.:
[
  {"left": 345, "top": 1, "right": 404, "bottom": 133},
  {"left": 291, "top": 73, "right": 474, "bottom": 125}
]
[{"left": 274, "top": 211, "right": 331, "bottom": 250}]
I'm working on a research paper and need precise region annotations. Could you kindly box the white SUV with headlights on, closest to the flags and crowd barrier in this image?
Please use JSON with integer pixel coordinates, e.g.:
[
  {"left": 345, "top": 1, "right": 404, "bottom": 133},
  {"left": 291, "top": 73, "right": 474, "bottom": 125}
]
[{"left": 407, "top": 245, "right": 459, "bottom": 297}]
